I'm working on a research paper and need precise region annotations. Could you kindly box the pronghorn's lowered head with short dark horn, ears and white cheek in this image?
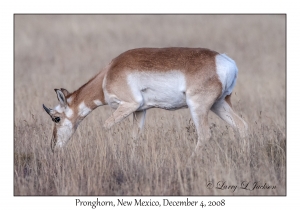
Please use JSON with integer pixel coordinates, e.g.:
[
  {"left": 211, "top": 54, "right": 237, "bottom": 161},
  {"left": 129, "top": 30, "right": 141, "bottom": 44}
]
[{"left": 43, "top": 88, "right": 76, "bottom": 151}]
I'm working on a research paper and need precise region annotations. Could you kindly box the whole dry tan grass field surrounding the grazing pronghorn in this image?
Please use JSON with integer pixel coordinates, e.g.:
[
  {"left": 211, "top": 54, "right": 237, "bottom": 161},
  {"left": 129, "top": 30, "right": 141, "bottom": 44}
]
[{"left": 13, "top": 15, "right": 286, "bottom": 195}]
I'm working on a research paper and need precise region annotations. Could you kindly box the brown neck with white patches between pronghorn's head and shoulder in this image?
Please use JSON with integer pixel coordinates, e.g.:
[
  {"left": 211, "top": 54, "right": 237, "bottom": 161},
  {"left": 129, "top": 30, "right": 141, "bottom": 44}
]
[{"left": 67, "top": 69, "right": 106, "bottom": 121}]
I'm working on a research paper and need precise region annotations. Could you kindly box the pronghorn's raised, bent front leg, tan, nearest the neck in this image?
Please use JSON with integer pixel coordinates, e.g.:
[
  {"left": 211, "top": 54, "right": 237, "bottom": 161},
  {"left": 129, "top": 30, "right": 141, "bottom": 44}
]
[{"left": 104, "top": 102, "right": 140, "bottom": 129}]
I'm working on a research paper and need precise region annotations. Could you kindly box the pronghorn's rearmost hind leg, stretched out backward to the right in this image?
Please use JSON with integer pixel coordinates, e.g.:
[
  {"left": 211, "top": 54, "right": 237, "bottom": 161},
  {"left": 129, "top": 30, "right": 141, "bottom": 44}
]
[{"left": 211, "top": 95, "right": 248, "bottom": 138}]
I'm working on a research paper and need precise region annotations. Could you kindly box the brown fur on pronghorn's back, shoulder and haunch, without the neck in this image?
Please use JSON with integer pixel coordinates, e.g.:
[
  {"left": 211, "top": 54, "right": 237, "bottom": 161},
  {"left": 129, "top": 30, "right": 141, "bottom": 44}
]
[{"left": 106, "top": 47, "right": 222, "bottom": 103}]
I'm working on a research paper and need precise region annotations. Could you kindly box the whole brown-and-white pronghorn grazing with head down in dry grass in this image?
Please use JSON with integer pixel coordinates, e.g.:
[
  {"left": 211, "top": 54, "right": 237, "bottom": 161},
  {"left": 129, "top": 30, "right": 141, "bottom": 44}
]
[{"left": 43, "top": 48, "right": 247, "bottom": 153}]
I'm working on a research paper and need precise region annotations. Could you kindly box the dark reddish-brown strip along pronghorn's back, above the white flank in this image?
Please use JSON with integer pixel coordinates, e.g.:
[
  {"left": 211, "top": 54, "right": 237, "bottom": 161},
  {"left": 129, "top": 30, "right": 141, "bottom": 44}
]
[{"left": 112, "top": 47, "right": 219, "bottom": 71}]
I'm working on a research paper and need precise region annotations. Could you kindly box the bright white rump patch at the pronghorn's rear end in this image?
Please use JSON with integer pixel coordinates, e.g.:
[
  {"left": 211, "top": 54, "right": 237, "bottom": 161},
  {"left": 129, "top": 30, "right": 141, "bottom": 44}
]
[{"left": 216, "top": 54, "right": 238, "bottom": 99}]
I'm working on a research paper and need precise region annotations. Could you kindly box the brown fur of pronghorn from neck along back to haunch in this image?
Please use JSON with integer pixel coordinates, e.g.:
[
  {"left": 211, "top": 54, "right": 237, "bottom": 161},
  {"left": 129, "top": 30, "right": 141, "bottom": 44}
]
[{"left": 67, "top": 48, "right": 222, "bottom": 108}]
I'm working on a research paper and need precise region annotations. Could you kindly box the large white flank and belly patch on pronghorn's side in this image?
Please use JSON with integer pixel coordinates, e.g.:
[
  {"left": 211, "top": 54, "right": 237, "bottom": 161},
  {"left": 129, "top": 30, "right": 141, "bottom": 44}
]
[{"left": 127, "top": 70, "right": 187, "bottom": 110}]
